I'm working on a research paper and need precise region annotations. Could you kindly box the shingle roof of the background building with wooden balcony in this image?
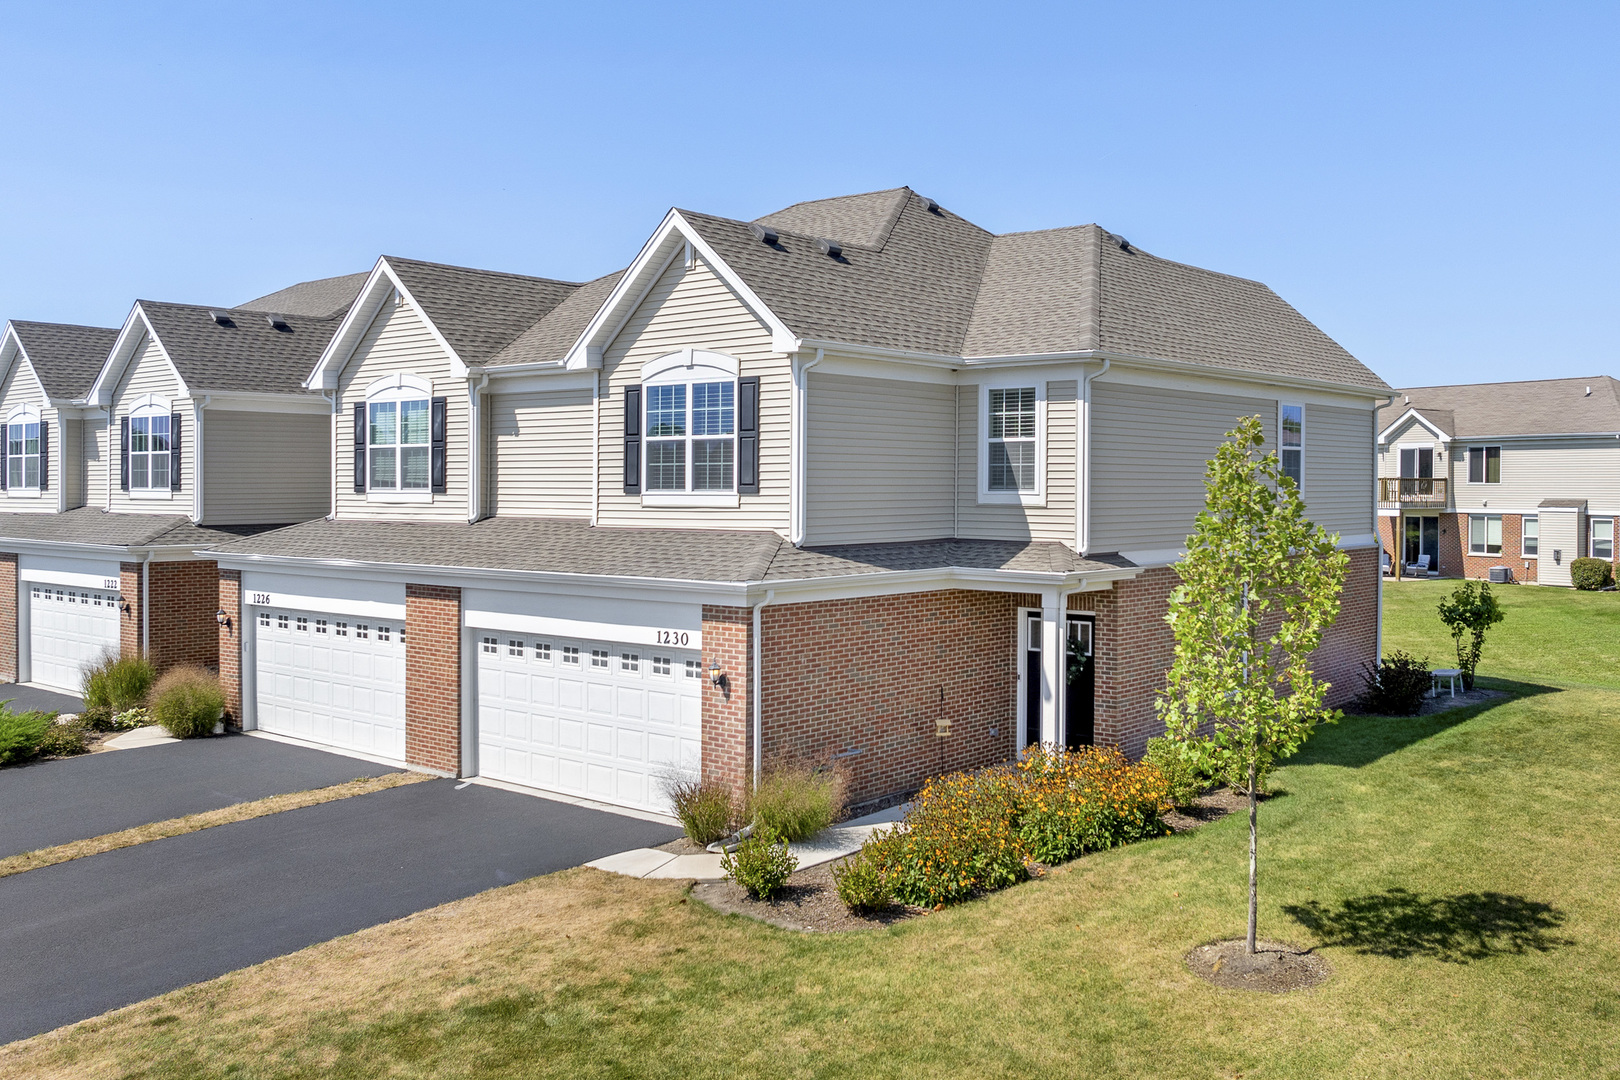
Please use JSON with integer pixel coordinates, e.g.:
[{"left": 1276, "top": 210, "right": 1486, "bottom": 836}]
[{"left": 1379, "top": 376, "right": 1620, "bottom": 439}]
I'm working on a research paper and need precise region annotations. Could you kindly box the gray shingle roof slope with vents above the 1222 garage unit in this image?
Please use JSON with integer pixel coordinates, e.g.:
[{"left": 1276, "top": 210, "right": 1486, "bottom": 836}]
[{"left": 136, "top": 300, "right": 340, "bottom": 393}]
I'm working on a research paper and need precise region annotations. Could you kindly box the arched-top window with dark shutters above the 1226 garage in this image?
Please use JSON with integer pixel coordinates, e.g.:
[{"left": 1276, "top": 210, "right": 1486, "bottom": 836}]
[{"left": 355, "top": 374, "right": 446, "bottom": 499}]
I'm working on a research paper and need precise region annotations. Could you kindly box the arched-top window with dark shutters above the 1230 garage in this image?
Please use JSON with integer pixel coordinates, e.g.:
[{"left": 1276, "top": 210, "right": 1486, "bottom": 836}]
[{"left": 624, "top": 350, "right": 760, "bottom": 507}]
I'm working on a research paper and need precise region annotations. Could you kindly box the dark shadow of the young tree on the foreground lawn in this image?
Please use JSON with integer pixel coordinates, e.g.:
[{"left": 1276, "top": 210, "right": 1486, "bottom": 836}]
[{"left": 1283, "top": 889, "right": 1575, "bottom": 963}]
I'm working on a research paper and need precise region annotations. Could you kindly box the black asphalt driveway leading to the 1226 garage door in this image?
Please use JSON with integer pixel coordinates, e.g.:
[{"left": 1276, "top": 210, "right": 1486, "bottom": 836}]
[{"left": 0, "top": 735, "right": 399, "bottom": 858}]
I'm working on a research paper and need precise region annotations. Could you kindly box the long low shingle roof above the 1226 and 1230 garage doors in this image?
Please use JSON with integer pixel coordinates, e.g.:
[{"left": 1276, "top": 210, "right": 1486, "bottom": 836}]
[{"left": 202, "top": 518, "right": 1129, "bottom": 581}]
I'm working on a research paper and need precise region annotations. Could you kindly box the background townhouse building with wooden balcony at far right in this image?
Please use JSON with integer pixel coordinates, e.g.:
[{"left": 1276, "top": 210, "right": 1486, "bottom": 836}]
[{"left": 1377, "top": 376, "right": 1620, "bottom": 586}]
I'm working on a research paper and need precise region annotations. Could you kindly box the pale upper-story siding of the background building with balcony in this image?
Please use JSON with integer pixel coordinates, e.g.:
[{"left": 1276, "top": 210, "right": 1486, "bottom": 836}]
[{"left": 1435, "top": 439, "right": 1620, "bottom": 514}]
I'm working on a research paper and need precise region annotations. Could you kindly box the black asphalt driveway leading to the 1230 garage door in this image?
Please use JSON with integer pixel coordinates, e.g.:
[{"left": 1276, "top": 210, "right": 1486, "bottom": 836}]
[{"left": 0, "top": 777, "right": 679, "bottom": 1043}]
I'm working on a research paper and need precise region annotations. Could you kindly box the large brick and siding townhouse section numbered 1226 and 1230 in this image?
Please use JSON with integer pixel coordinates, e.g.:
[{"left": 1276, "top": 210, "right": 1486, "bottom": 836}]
[{"left": 196, "top": 188, "right": 1390, "bottom": 810}]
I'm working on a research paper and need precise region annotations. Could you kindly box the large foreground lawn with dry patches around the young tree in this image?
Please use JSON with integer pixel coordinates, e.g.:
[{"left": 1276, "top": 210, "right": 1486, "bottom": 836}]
[{"left": 0, "top": 687, "right": 1620, "bottom": 1080}]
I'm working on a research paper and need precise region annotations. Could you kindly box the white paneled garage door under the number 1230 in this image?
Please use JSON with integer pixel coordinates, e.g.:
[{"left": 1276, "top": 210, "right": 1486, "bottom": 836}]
[{"left": 478, "top": 631, "right": 703, "bottom": 811}]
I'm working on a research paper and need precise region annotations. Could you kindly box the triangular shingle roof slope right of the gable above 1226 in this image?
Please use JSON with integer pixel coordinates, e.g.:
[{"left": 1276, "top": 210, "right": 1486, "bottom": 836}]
[{"left": 384, "top": 256, "right": 595, "bottom": 364}]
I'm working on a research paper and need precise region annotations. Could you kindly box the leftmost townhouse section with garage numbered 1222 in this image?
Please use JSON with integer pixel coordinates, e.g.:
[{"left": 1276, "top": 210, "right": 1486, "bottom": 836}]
[{"left": 0, "top": 274, "right": 365, "bottom": 691}]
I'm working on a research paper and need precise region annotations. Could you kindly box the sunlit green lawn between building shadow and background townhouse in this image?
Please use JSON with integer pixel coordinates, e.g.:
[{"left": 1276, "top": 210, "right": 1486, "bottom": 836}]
[{"left": 1383, "top": 580, "right": 1620, "bottom": 688}]
